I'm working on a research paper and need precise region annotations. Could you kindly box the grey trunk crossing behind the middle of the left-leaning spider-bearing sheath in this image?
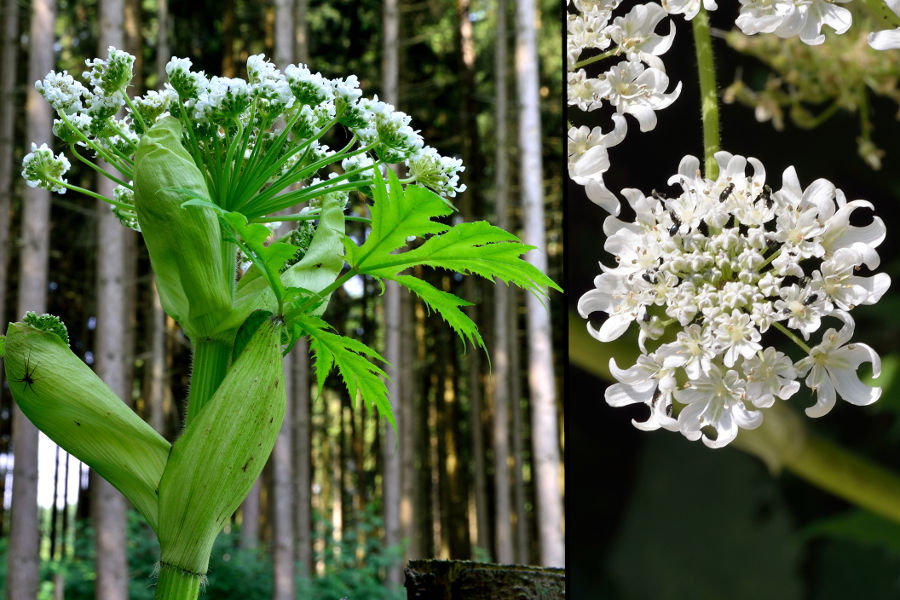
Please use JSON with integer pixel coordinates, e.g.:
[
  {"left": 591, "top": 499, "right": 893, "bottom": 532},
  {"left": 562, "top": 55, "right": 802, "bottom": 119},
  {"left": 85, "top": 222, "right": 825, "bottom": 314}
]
[{"left": 91, "top": 0, "right": 131, "bottom": 600}]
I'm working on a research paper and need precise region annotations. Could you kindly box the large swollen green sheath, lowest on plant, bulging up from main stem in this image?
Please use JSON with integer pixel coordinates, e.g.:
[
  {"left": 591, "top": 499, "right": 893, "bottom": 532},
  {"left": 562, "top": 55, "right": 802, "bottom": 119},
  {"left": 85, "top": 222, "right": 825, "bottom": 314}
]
[{"left": 158, "top": 318, "right": 285, "bottom": 577}]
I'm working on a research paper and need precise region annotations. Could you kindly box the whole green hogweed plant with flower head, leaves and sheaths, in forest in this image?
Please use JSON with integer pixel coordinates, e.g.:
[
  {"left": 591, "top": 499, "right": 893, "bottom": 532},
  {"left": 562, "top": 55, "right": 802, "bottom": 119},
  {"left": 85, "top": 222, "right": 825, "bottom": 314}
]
[{"left": 0, "top": 48, "right": 559, "bottom": 599}]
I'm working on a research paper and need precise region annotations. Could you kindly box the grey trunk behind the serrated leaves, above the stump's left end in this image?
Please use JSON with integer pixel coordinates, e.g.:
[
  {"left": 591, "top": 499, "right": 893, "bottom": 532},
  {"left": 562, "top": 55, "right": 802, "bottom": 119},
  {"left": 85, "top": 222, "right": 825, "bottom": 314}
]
[{"left": 381, "top": 0, "right": 407, "bottom": 586}]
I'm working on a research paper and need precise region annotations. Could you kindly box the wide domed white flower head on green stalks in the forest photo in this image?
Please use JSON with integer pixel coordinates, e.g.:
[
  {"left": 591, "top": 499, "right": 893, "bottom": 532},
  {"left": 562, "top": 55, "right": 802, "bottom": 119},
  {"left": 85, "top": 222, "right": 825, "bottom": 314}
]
[{"left": 22, "top": 47, "right": 465, "bottom": 227}]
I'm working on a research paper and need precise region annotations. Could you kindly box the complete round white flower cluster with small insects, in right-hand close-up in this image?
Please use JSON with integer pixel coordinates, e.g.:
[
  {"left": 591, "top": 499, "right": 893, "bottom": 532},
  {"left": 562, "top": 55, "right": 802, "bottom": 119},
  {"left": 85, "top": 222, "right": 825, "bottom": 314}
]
[{"left": 578, "top": 152, "right": 890, "bottom": 448}]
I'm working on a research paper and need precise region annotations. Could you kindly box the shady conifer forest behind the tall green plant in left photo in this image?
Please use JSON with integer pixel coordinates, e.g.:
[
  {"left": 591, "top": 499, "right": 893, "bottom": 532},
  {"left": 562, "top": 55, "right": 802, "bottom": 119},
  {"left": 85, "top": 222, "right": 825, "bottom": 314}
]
[{"left": 0, "top": 0, "right": 565, "bottom": 600}]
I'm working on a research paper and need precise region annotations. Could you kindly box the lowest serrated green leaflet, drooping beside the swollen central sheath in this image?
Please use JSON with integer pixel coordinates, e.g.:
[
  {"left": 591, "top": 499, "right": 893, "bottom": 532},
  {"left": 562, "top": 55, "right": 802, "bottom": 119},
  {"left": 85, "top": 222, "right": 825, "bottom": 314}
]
[{"left": 294, "top": 315, "right": 397, "bottom": 430}]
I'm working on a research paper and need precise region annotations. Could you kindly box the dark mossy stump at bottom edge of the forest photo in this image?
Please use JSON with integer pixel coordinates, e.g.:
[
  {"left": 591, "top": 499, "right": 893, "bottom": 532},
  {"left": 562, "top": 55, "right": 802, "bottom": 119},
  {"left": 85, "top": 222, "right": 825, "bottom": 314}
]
[{"left": 404, "top": 560, "right": 566, "bottom": 600}]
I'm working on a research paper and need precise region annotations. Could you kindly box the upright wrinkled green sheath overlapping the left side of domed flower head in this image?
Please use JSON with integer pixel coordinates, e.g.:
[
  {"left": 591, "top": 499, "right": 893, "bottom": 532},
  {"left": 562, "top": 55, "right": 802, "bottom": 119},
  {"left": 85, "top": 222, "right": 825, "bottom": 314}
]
[{"left": 134, "top": 117, "right": 233, "bottom": 341}]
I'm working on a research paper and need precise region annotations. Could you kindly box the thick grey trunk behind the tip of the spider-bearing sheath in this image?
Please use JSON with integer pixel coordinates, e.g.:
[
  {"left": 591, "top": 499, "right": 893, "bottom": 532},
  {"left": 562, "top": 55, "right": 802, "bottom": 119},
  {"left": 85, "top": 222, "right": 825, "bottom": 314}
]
[{"left": 6, "top": 0, "right": 56, "bottom": 600}]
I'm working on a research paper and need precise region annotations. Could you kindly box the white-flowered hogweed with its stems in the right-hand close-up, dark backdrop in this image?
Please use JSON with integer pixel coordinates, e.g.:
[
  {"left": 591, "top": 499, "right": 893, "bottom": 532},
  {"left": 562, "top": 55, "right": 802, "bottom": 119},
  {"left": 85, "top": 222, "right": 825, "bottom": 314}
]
[{"left": 567, "top": 0, "right": 900, "bottom": 521}]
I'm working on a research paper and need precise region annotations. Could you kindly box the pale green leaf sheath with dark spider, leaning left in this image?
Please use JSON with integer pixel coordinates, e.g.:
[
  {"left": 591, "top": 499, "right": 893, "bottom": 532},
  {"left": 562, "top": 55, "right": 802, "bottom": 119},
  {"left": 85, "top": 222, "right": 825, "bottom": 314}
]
[{"left": 4, "top": 323, "right": 171, "bottom": 529}]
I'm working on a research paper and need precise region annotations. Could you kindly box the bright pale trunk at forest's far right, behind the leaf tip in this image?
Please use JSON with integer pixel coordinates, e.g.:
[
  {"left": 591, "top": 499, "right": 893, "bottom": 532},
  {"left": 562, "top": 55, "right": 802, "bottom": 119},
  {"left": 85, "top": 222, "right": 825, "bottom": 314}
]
[{"left": 516, "top": 0, "right": 565, "bottom": 567}]
